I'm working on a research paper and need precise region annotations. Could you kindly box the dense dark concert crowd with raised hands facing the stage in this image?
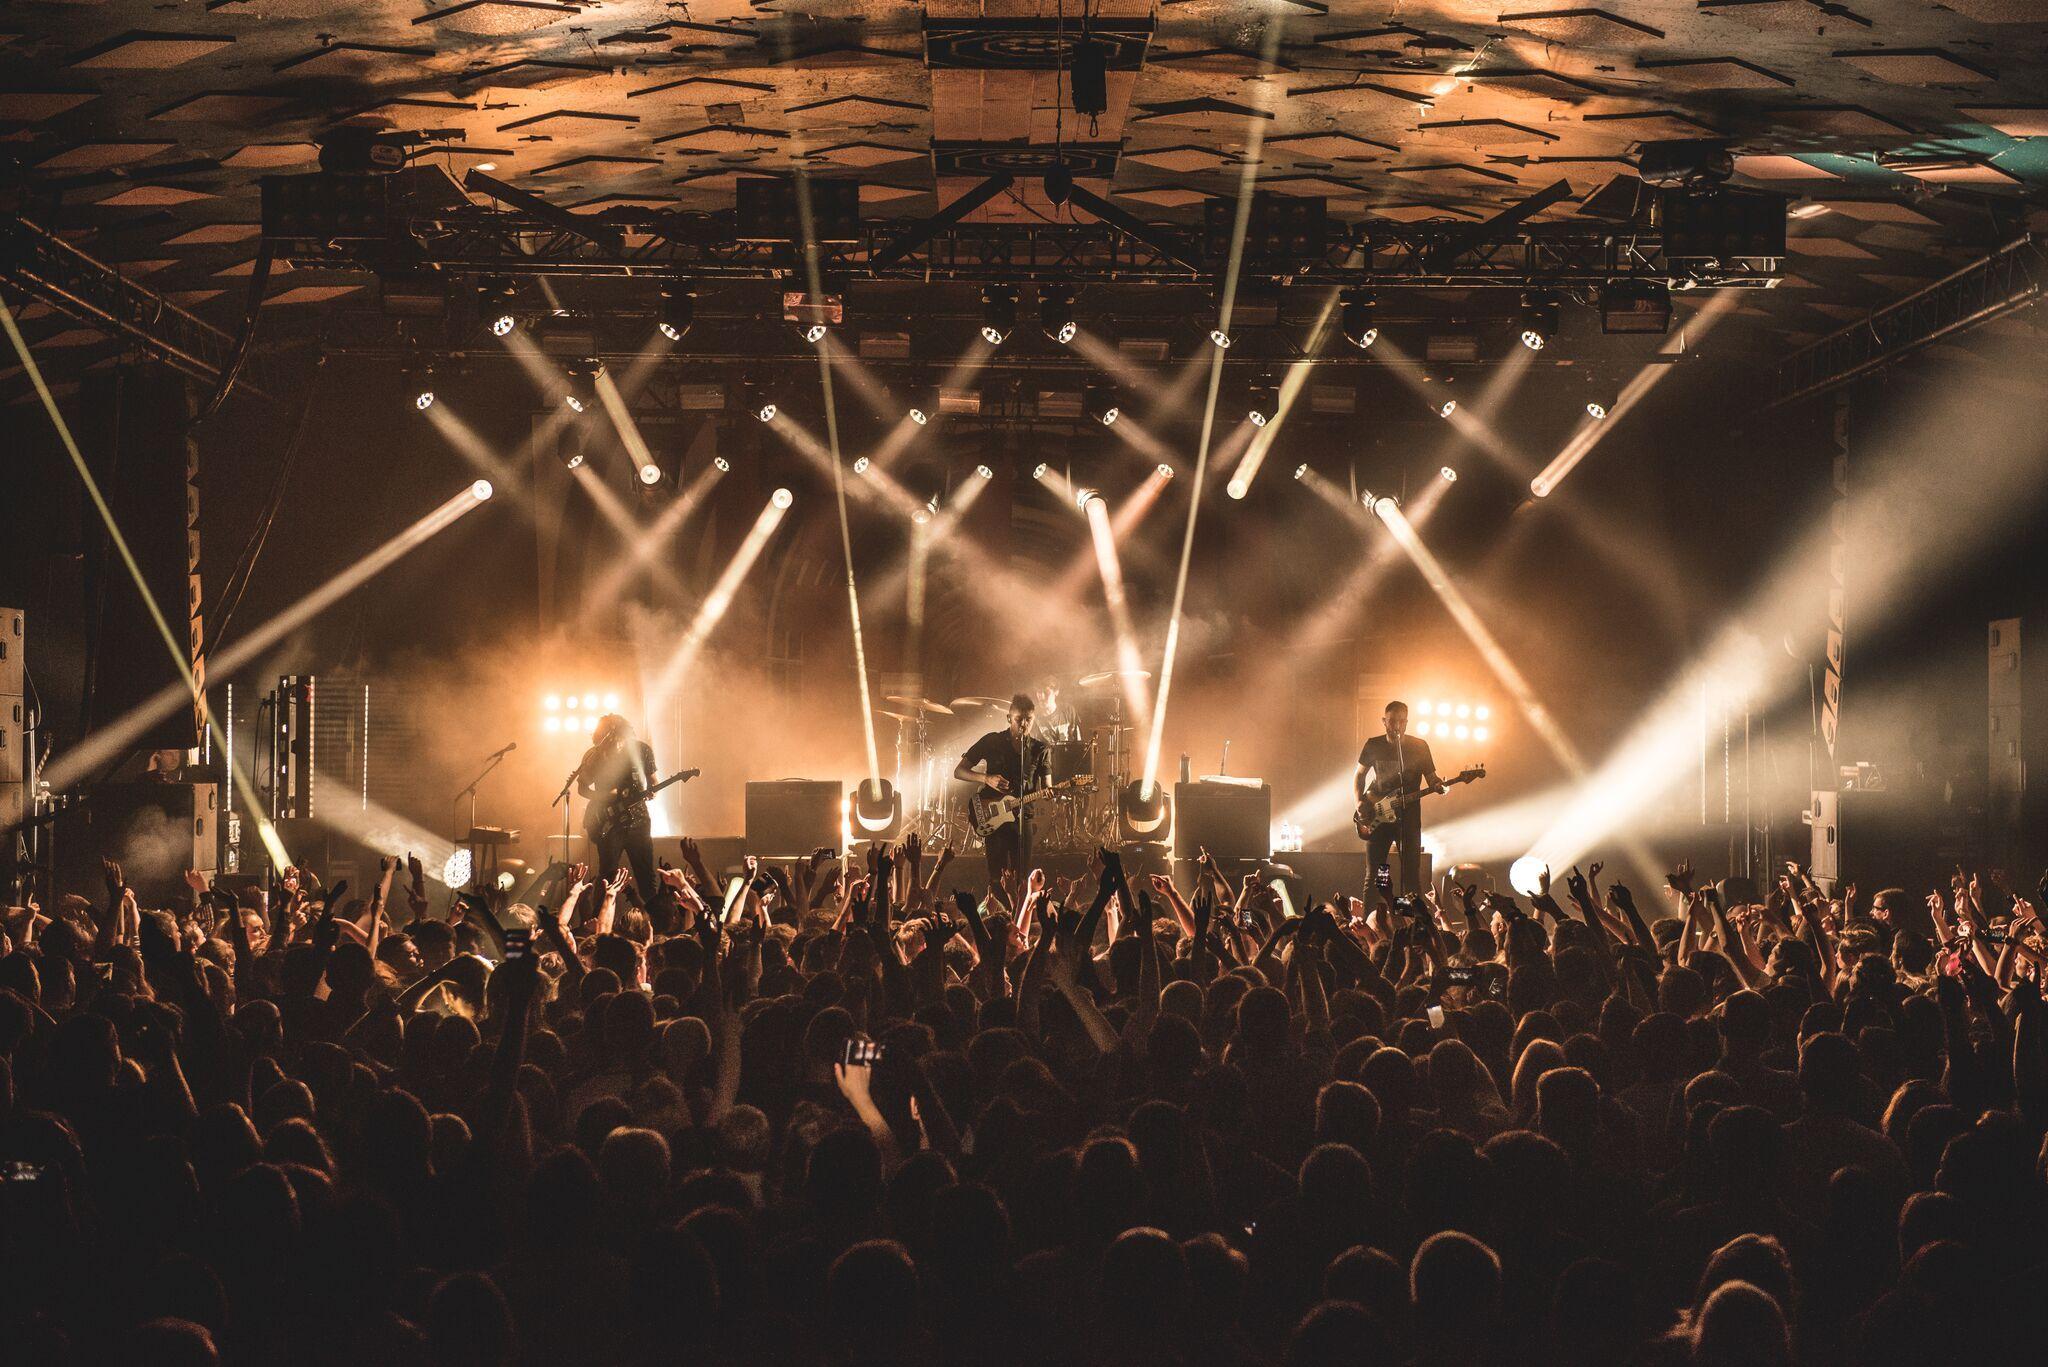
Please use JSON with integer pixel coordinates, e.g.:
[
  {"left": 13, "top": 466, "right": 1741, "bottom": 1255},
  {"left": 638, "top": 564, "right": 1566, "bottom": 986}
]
[{"left": 0, "top": 840, "right": 2048, "bottom": 1367}]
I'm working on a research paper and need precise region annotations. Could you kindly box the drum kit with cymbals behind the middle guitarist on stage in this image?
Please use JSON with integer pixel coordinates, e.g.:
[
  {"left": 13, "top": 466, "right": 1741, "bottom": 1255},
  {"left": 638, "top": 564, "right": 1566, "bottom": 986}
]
[{"left": 874, "top": 670, "right": 1151, "bottom": 853}]
